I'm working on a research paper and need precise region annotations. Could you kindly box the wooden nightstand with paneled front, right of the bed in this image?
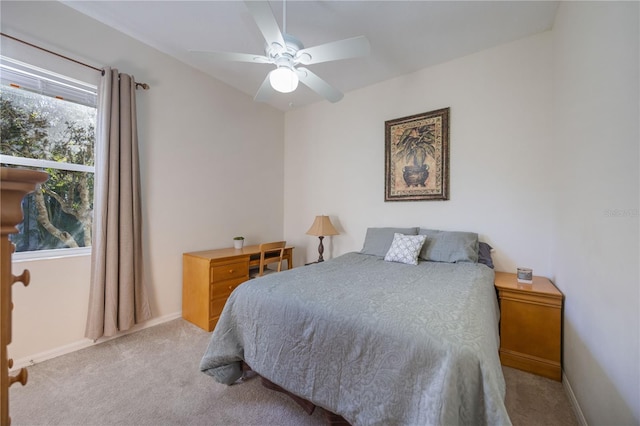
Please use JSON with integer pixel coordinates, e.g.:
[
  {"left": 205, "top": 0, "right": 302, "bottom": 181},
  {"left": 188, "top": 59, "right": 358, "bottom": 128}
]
[{"left": 495, "top": 272, "right": 563, "bottom": 381}]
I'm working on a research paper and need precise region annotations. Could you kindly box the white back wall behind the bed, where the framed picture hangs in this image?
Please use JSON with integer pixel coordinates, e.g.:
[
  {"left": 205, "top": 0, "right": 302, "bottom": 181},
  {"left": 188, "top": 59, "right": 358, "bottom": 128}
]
[{"left": 285, "top": 32, "right": 552, "bottom": 275}]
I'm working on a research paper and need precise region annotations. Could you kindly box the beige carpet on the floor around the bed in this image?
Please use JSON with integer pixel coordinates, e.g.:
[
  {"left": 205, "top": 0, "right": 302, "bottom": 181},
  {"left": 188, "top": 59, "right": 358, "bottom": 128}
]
[{"left": 9, "top": 319, "right": 577, "bottom": 426}]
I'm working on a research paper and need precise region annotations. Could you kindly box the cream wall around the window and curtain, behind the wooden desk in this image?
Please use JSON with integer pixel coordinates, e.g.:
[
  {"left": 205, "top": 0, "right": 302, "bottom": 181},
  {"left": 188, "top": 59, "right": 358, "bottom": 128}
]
[{"left": 0, "top": 1, "right": 284, "bottom": 360}]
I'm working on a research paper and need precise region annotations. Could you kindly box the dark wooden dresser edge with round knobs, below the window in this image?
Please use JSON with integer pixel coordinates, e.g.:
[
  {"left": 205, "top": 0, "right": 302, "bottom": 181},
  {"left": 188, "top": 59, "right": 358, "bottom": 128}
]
[{"left": 0, "top": 167, "right": 47, "bottom": 426}]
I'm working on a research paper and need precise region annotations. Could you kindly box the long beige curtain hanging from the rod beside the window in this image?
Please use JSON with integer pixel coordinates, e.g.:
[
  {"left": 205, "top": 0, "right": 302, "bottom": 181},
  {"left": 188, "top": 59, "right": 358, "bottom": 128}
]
[{"left": 85, "top": 68, "right": 151, "bottom": 340}]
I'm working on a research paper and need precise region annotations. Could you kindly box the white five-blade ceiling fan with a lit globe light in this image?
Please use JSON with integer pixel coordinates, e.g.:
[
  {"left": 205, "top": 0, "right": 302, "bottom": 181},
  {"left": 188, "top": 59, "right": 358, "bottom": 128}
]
[{"left": 191, "top": 0, "right": 370, "bottom": 102}]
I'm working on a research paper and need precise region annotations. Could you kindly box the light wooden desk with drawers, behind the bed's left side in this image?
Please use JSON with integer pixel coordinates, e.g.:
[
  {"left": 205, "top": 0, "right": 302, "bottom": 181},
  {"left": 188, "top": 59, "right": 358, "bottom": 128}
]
[{"left": 182, "top": 245, "right": 293, "bottom": 331}]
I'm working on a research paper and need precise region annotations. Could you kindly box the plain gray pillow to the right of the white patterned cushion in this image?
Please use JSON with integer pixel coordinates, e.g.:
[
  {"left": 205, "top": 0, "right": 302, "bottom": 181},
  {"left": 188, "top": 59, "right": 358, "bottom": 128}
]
[{"left": 420, "top": 229, "right": 478, "bottom": 263}]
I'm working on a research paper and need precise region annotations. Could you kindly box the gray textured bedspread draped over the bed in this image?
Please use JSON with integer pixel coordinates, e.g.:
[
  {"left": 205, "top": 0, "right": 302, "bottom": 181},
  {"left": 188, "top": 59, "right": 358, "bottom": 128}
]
[{"left": 200, "top": 252, "right": 511, "bottom": 425}]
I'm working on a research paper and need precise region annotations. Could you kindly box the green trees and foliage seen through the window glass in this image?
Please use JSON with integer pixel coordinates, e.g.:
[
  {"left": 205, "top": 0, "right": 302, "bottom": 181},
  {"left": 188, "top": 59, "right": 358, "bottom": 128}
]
[{"left": 0, "top": 87, "right": 96, "bottom": 252}]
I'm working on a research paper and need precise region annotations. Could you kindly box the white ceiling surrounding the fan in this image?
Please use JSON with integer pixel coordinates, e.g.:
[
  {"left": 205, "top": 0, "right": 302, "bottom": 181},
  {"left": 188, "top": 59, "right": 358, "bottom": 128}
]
[{"left": 63, "top": 0, "right": 558, "bottom": 111}]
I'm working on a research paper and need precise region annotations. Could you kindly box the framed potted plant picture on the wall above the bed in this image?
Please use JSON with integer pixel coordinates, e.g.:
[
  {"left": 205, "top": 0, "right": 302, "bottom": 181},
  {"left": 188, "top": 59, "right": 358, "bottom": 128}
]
[{"left": 384, "top": 108, "right": 449, "bottom": 201}]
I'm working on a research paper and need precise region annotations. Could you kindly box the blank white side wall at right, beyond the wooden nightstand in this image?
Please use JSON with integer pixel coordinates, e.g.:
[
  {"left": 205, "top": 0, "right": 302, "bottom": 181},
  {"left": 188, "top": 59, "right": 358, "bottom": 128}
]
[{"left": 552, "top": 2, "right": 640, "bottom": 425}]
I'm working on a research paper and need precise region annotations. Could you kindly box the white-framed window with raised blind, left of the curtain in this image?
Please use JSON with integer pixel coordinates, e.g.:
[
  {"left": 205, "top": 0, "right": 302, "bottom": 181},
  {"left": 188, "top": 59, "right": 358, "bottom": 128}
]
[{"left": 0, "top": 57, "right": 97, "bottom": 258}]
